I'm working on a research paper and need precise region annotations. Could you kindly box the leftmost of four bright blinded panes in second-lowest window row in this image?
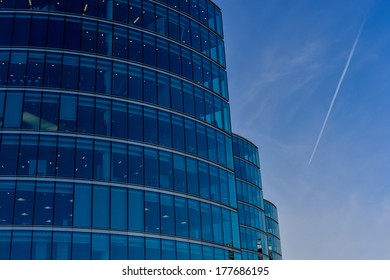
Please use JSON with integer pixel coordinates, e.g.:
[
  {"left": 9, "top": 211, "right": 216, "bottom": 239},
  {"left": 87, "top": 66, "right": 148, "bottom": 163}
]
[{"left": 74, "top": 184, "right": 92, "bottom": 227}]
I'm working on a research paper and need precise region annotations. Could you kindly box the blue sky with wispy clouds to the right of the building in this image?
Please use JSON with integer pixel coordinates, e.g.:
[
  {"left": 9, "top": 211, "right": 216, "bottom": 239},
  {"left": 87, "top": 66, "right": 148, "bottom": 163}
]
[{"left": 215, "top": 0, "right": 390, "bottom": 259}]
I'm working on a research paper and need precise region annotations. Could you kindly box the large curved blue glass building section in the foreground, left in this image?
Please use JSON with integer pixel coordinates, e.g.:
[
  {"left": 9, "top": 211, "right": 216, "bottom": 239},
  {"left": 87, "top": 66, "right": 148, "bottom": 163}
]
[{"left": 0, "top": 0, "right": 280, "bottom": 259}]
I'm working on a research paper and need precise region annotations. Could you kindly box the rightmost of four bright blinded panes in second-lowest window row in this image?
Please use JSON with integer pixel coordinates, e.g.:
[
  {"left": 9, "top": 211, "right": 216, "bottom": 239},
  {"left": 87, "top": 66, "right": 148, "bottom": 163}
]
[{"left": 128, "top": 189, "right": 145, "bottom": 231}]
